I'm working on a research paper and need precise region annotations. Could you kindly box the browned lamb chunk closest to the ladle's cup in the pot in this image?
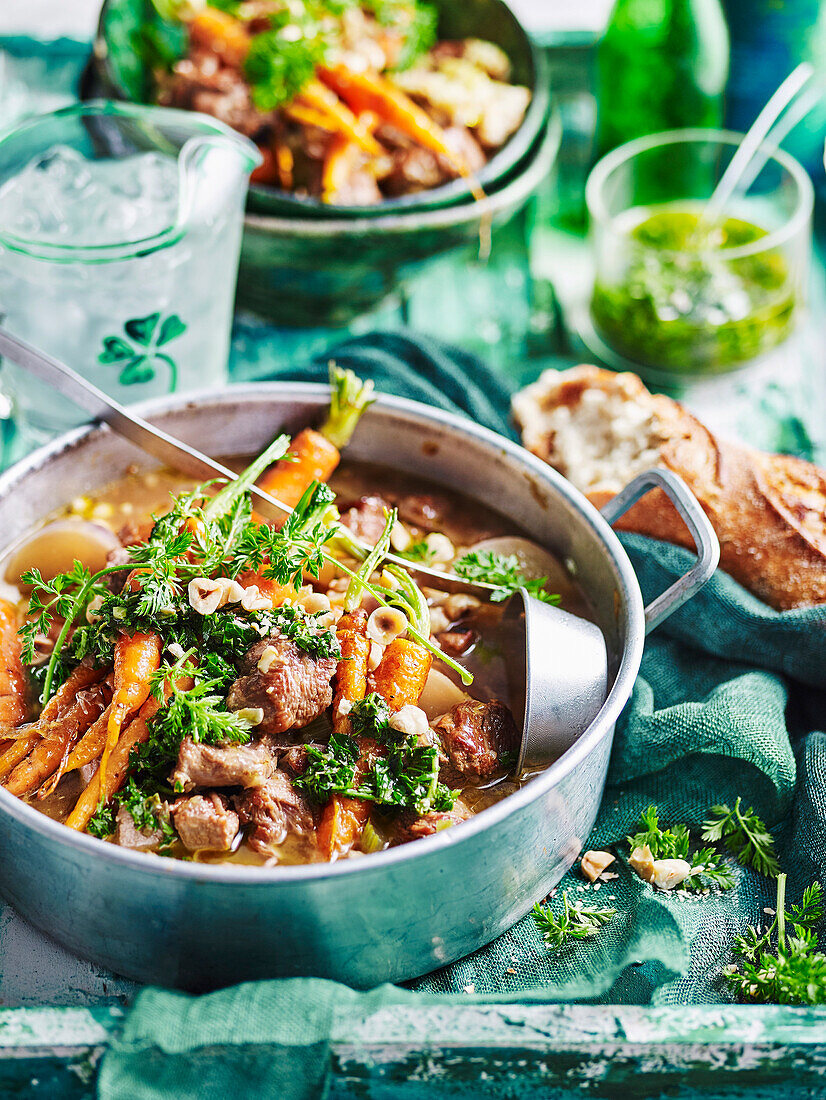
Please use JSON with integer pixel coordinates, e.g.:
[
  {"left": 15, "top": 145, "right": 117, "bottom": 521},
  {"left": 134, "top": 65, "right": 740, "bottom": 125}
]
[{"left": 433, "top": 699, "right": 519, "bottom": 779}]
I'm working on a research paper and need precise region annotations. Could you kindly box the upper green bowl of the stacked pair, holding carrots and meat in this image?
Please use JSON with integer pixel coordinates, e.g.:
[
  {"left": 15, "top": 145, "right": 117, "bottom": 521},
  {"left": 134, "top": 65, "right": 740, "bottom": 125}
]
[{"left": 93, "top": 0, "right": 550, "bottom": 220}]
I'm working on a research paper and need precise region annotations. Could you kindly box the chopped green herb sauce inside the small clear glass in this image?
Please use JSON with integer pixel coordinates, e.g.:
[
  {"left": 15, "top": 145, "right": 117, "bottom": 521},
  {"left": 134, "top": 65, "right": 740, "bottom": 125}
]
[{"left": 591, "top": 206, "right": 796, "bottom": 374}]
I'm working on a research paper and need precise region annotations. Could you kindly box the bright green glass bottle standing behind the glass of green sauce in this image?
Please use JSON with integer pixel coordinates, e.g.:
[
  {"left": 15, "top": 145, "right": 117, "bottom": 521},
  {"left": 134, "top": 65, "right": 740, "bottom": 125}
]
[{"left": 596, "top": 0, "right": 728, "bottom": 156}]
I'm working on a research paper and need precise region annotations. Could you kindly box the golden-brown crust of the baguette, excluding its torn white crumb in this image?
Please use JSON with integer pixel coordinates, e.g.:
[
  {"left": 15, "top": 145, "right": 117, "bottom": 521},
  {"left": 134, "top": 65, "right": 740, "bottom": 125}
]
[{"left": 516, "top": 367, "right": 826, "bottom": 611}]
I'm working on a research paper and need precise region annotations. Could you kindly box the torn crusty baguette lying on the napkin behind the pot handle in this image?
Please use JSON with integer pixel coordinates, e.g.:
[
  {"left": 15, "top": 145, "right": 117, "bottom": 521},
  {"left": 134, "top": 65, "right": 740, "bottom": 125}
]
[{"left": 514, "top": 366, "right": 826, "bottom": 611}]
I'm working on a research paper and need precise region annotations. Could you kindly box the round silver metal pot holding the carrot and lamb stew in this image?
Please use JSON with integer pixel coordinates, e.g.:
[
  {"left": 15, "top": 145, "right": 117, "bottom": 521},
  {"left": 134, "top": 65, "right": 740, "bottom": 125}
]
[{"left": 0, "top": 383, "right": 716, "bottom": 990}]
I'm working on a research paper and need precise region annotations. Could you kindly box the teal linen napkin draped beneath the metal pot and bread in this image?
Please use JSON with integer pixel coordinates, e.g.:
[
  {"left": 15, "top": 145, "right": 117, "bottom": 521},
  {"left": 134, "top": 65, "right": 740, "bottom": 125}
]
[{"left": 99, "top": 333, "right": 826, "bottom": 1100}]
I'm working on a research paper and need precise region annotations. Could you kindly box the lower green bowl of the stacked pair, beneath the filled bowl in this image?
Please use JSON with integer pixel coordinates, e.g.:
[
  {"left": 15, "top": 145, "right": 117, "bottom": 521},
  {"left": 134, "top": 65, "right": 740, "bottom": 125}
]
[{"left": 238, "top": 112, "right": 561, "bottom": 327}]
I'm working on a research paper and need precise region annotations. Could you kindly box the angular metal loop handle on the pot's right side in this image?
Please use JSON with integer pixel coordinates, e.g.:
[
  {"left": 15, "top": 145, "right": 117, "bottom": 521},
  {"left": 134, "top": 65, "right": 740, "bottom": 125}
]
[{"left": 601, "top": 469, "right": 720, "bottom": 634}]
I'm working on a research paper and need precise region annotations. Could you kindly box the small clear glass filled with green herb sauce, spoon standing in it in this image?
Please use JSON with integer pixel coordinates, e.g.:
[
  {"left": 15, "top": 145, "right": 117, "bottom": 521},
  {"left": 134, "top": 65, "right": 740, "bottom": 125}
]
[{"left": 585, "top": 130, "right": 813, "bottom": 377}]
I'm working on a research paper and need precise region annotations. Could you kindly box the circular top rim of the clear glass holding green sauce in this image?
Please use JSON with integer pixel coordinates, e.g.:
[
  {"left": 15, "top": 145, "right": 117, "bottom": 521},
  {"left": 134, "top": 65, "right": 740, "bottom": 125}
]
[{"left": 585, "top": 128, "right": 814, "bottom": 261}]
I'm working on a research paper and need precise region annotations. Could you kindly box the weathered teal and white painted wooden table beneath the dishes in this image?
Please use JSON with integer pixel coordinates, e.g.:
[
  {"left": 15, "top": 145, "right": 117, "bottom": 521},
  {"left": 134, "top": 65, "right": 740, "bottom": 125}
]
[{"left": 0, "top": 30, "right": 826, "bottom": 1100}]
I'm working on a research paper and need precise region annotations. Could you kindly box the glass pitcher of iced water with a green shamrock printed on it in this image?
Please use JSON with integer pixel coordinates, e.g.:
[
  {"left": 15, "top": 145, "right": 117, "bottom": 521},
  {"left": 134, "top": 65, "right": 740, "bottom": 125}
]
[{"left": 0, "top": 101, "right": 261, "bottom": 439}]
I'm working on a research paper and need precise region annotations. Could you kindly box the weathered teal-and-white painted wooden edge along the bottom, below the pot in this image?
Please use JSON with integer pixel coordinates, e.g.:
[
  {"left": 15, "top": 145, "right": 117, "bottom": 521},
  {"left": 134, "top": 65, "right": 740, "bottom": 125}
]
[{"left": 0, "top": 1004, "right": 826, "bottom": 1100}]
